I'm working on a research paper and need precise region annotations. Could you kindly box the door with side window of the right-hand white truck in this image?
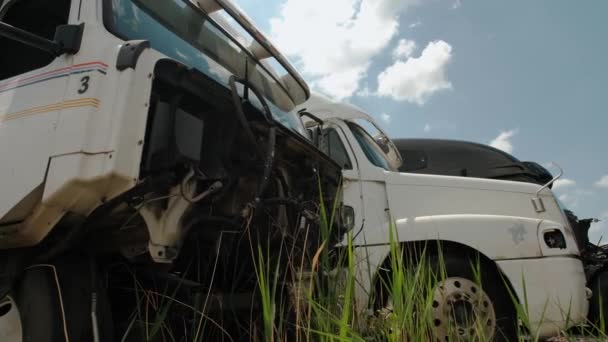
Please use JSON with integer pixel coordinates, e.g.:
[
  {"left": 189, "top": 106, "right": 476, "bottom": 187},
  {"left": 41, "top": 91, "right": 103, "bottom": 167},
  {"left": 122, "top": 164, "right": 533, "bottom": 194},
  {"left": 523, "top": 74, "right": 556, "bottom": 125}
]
[{"left": 320, "top": 124, "right": 365, "bottom": 239}]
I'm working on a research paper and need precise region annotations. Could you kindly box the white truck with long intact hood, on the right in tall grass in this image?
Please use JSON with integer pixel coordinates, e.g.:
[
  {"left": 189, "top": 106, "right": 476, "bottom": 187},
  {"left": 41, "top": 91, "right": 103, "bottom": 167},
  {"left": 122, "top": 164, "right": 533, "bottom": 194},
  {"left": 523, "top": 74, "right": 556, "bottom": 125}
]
[{"left": 299, "top": 95, "right": 590, "bottom": 341}]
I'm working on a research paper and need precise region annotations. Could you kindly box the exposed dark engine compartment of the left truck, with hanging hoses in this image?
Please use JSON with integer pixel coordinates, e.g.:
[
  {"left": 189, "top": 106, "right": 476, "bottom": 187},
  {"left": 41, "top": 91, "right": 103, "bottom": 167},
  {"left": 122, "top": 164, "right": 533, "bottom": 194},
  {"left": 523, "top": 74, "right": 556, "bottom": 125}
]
[{"left": 66, "top": 61, "right": 344, "bottom": 338}]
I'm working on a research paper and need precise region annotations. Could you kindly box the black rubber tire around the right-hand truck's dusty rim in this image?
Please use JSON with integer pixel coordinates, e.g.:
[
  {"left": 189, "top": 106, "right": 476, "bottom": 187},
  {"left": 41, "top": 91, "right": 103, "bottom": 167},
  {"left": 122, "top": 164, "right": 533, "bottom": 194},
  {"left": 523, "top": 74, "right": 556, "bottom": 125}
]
[{"left": 380, "top": 254, "right": 518, "bottom": 342}]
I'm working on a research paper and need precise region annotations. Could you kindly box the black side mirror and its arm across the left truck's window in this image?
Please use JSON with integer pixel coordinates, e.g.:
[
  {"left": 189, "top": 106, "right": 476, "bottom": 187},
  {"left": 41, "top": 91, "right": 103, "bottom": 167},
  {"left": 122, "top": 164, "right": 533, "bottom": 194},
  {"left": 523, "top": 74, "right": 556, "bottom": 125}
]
[{"left": 0, "top": 21, "right": 84, "bottom": 56}]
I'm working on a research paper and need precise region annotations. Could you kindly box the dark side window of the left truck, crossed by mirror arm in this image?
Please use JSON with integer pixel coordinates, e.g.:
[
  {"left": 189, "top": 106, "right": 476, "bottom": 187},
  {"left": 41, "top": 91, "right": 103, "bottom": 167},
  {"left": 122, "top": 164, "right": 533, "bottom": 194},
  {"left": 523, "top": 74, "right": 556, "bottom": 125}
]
[{"left": 0, "top": 0, "right": 70, "bottom": 80}]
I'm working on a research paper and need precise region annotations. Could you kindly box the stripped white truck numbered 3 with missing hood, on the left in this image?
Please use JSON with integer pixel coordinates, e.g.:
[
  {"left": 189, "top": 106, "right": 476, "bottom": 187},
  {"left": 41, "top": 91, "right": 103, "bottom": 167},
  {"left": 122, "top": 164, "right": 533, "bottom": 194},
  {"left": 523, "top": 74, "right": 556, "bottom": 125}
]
[{"left": 0, "top": 0, "right": 341, "bottom": 342}]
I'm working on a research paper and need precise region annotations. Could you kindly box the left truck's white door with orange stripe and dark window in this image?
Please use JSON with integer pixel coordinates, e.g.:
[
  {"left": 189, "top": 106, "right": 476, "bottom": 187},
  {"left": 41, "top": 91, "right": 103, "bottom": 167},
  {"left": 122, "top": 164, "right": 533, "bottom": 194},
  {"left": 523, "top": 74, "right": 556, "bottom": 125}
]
[{"left": 0, "top": 0, "right": 73, "bottom": 222}]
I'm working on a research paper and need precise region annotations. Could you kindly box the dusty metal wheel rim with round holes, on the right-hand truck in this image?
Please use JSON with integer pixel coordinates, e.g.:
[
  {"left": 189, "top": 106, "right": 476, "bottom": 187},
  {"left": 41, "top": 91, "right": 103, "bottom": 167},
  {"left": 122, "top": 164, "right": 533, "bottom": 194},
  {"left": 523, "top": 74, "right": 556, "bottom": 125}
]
[{"left": 432, "top": 277, "right": 496, "bottom": 341}]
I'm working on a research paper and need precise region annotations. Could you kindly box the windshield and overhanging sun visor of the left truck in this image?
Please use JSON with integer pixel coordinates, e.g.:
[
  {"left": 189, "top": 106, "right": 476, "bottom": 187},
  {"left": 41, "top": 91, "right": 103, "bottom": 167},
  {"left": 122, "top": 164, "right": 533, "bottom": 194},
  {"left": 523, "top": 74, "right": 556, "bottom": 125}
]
[{"left": 103, "top": 0, "right": 306, "bottom": 136}]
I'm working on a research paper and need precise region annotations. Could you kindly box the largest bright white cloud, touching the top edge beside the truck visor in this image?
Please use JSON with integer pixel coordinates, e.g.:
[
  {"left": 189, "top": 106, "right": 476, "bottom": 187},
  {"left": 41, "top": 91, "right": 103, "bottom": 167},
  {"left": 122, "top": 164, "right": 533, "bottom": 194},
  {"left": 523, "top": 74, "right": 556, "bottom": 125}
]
[{"left": 270, "top": 0, "right": 419, "bottom": 100}]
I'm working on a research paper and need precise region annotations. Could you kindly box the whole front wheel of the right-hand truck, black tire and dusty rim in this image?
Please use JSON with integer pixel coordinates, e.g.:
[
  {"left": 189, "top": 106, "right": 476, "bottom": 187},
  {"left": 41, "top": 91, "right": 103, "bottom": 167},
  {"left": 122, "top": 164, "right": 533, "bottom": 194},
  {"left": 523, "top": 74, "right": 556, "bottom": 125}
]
[{"left": 377, "top": 250, "right": 517, "bottom": 341}]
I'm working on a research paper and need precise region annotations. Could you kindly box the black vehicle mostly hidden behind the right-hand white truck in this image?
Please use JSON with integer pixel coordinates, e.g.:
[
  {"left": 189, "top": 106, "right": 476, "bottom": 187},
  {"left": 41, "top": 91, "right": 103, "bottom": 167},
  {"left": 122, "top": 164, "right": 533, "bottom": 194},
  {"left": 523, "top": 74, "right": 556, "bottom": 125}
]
[{"left": 394, "top": 139, "right": 608, "bottom": 332}]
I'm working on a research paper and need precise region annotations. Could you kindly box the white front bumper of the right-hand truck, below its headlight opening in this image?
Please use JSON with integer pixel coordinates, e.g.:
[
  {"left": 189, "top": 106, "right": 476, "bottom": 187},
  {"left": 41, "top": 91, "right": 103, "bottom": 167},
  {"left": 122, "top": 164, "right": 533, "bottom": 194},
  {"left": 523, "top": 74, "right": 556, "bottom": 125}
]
[{"left": 496, "top": 256, "right": 589, "bottom": 337}]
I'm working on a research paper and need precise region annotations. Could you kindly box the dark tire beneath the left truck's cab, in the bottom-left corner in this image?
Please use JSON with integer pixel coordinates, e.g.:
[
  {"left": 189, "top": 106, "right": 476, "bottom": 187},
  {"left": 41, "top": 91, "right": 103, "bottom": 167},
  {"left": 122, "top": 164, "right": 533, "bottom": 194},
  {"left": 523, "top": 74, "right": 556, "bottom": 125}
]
[{"left": 0, "top": 256, "right": 113, "bottom": 342}]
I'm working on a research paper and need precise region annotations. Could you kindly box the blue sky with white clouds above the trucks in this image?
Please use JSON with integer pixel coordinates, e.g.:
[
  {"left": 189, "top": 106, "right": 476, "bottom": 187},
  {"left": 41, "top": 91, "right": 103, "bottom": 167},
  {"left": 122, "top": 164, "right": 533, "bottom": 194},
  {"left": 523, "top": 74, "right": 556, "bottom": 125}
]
[{"left": 234, "top": 0, "right": 608, "bottom": 242}]
